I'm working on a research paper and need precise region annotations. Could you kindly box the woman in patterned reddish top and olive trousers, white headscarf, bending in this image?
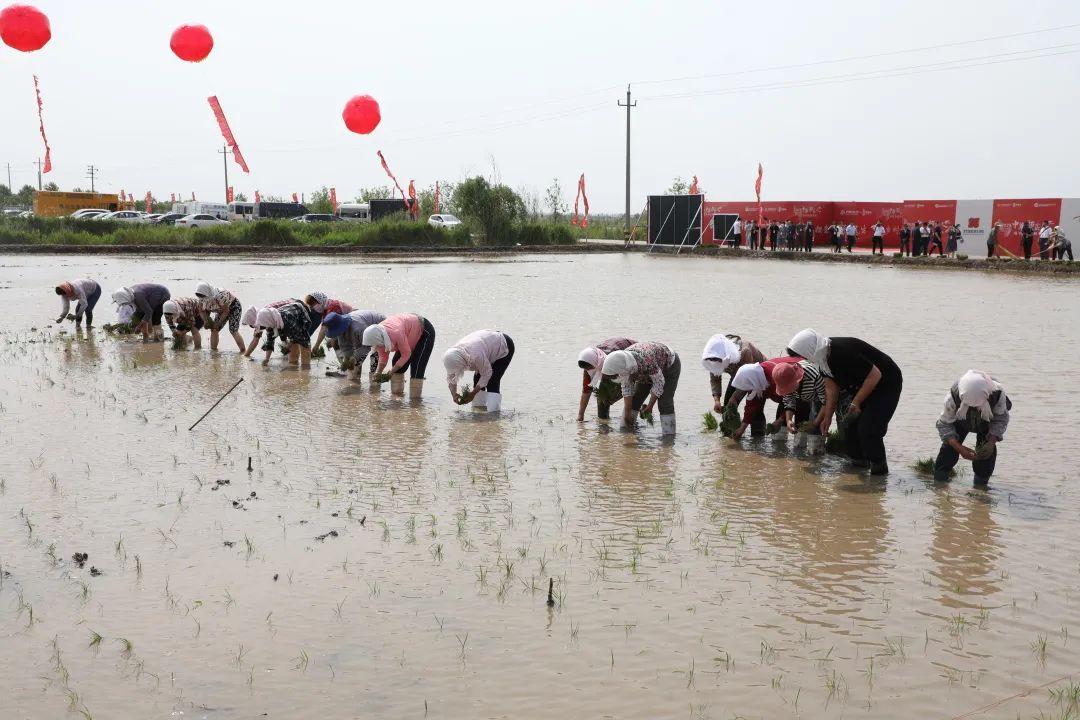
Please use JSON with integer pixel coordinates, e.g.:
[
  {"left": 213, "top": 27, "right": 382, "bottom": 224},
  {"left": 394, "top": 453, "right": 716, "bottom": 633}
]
[{"left": 604, "top": 342, "right": 683, "bottom": 437}]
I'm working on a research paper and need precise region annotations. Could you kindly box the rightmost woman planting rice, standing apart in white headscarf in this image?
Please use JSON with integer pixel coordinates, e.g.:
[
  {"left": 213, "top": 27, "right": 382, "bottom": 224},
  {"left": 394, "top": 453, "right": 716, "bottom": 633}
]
[{"left": 934, "top": 370, "right": 1012, "bottom": 486}]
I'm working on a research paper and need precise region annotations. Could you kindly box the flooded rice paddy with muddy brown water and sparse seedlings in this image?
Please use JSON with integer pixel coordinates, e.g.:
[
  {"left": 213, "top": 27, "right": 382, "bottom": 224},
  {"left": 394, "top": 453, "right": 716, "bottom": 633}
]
[{"left": 0, "top": 256, "right": 1080, "bottom": 719}]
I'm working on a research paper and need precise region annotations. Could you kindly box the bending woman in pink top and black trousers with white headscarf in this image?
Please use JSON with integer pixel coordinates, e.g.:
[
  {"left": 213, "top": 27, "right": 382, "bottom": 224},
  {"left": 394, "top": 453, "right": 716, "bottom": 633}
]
[{"left": 364, "top": 313, "right": 435, "bottom": 399}]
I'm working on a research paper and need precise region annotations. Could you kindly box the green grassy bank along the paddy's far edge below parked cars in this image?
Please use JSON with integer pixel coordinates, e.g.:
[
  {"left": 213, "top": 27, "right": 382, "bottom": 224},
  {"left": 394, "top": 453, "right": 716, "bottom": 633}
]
[{"left": 0, "top": 218, "right": 575, "bottom": 248}]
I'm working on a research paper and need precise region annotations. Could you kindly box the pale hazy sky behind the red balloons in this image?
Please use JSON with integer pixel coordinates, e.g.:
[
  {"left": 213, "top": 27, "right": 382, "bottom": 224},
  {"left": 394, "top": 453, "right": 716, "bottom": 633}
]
[{"left": 0, "top": 0, "right": 1080, "bottom": 212}]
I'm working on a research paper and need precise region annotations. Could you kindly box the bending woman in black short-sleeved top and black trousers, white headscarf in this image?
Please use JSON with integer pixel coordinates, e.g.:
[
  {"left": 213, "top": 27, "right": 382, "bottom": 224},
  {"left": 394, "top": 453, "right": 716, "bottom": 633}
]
[{"left": 787, "top": 329, "right": 904, "bottom": 475}]
